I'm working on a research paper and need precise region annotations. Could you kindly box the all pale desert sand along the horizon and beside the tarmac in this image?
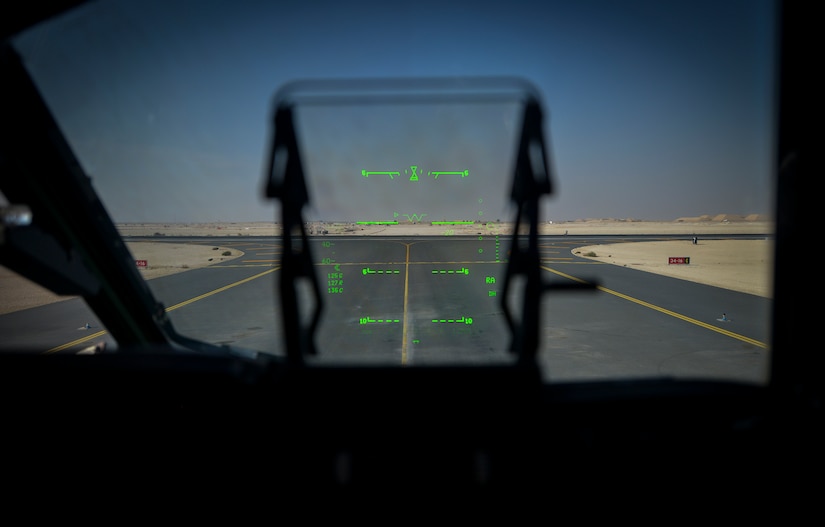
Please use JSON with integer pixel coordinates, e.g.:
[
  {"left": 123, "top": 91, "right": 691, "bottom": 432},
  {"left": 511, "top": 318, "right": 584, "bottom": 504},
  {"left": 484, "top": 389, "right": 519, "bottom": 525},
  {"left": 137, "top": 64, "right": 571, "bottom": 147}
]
[{"left": 0, "top": 215, "right": 774, "bottom": 314}]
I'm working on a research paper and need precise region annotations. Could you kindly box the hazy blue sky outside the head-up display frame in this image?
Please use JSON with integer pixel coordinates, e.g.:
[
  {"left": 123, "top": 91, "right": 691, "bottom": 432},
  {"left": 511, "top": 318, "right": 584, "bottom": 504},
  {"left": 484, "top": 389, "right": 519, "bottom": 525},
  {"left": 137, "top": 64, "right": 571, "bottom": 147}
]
[{"left": 9, "top": 0, "right": 776, "bottom": 222}]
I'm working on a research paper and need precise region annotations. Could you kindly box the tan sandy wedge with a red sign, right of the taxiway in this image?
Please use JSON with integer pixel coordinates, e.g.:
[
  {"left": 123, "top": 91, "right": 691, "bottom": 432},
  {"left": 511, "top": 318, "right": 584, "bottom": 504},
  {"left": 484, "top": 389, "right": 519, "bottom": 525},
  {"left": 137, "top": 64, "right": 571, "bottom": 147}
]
[{"left": 572, "top": 239, "right": 774, "bottom": 298}]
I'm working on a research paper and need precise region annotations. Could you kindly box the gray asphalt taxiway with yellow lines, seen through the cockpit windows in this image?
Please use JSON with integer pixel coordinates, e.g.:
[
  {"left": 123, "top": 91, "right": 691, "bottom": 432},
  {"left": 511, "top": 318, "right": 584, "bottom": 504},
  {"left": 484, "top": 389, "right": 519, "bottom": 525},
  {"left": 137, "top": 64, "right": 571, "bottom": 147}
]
[{"left": 0, "top": 236, "right": 771, "bottom": 383}]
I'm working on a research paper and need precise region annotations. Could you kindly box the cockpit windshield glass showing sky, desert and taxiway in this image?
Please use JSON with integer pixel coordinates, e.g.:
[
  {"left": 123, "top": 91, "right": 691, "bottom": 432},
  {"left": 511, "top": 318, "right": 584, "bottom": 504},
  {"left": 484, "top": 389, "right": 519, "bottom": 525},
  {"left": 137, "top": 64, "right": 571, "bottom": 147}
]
[{"left": 0, "top": 0, "right": 776, "bottom": 385}]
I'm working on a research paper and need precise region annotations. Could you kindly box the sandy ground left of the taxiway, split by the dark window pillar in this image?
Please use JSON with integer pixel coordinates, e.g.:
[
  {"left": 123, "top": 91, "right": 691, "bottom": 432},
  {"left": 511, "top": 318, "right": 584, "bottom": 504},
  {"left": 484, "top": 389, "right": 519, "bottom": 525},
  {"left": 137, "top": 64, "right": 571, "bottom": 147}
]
[{"left": 0, "top": 242, "right": 244, "bottom": 315}]
